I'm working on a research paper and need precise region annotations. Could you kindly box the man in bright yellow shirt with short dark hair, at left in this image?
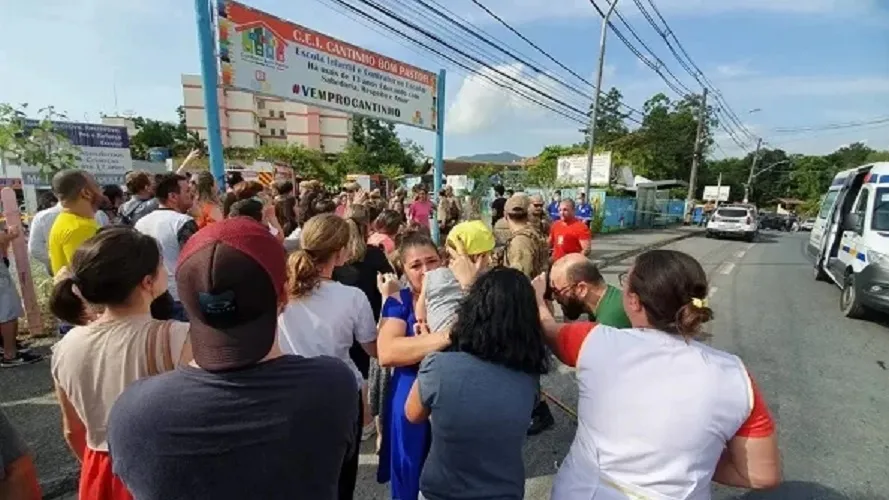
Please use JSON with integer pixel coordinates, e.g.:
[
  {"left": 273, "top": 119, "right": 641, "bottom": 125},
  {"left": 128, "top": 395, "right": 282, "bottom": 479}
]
[{"left": 48, "top": 170, "right": 102, "bottom": 276}]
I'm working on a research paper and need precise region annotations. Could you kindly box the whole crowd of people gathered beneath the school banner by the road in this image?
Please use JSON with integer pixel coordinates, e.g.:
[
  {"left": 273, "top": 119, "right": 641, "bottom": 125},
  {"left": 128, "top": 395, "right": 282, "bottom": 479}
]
[{"left": 0, "top": 170, "right": 781, "bottom": 500}]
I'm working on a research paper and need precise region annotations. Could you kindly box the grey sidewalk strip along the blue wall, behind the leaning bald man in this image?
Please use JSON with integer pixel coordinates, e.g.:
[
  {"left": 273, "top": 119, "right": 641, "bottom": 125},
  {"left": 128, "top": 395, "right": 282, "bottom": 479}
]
[{"left": 590, "top": 226, "right": 703, "bottom": 267}]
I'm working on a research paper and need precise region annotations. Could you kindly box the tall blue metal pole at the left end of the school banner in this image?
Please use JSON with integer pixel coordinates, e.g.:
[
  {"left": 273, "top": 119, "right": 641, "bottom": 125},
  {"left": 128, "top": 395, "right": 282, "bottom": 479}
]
[{"left": 194, "top": 0, "right": 225, "bottom": 189}]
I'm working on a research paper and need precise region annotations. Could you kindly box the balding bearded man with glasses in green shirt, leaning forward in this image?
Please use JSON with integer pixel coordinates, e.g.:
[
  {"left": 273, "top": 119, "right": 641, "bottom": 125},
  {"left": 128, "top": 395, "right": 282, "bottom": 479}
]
[{"left": 549, "top": 253, "right": 630, "bottom": 328}]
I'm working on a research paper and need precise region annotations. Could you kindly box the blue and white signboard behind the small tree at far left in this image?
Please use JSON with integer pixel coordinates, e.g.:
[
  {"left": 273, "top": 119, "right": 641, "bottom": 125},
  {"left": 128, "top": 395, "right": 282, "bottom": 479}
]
[{"left": 22, "top": 120, "right": 133, "bottom": 186}]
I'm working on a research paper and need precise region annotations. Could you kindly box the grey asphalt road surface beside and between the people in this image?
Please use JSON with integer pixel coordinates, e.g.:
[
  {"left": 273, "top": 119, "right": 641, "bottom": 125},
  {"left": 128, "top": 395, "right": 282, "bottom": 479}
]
[{"left": 6, "top": 233, "right": 889, "bottom": 500}]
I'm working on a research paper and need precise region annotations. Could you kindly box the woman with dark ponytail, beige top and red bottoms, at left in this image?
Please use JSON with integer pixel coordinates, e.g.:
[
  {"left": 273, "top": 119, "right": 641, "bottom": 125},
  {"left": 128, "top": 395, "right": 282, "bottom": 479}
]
[{"left": 50, "top": 227, "right": 191, "bottom": 500}]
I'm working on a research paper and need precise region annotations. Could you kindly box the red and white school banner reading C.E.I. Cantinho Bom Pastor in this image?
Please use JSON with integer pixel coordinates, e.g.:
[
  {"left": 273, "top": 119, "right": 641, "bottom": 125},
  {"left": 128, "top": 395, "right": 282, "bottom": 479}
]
[{"left": 217, "top": 1, "right": 437, "bottom": 130}]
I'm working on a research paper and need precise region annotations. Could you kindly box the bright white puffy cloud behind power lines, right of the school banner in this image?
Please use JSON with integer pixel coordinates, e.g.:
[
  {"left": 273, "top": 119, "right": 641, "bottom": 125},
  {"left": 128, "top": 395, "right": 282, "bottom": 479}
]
[{"left": 445, "top": 64, "right": 588, "bottom": 134}]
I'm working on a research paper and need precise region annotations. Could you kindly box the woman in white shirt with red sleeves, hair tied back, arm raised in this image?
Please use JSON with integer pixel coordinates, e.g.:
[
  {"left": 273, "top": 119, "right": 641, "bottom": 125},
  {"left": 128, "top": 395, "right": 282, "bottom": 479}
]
[{"left": 533, "top": 249, "right": 781, "bottom": 500}]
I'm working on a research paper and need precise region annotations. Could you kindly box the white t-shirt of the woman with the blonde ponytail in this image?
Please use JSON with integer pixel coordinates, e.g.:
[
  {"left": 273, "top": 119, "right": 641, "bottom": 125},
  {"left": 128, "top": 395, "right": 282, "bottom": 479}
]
[{"left": 278, "top": 280, "right": 377, "bottom": 387}]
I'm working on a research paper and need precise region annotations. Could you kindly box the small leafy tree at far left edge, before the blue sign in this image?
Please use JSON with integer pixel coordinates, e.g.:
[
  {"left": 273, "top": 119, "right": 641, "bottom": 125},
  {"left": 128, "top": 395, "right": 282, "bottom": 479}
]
[{"left": 0, "top": 103, "right": 80, "bottom": 179}]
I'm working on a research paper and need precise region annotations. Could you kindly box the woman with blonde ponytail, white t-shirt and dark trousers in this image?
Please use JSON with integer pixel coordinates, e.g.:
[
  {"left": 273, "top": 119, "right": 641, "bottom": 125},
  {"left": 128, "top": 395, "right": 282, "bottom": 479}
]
[{"left": 278, "top": 214, "right": 377, "bottom": 499}]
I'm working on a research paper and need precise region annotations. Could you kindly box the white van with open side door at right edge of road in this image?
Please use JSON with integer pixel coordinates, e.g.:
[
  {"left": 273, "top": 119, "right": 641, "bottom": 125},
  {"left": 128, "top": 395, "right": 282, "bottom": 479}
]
[{"left": 806, "top": 162, "right": 889, "bottom": 318}]
